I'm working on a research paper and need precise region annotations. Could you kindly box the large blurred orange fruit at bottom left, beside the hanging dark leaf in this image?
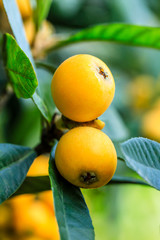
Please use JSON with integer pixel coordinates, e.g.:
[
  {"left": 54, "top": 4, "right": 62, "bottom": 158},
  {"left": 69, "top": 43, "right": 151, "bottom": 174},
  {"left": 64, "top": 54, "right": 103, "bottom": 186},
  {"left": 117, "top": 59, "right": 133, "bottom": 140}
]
[{"left": 13, "top": 195, "right": 59, "bottom": 239}]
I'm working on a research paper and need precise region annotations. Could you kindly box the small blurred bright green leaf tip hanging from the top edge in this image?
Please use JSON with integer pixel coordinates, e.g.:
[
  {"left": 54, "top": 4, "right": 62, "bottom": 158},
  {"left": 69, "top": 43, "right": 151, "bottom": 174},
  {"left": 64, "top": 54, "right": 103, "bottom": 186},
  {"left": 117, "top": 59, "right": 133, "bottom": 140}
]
[{"left": 34, "top": 0, "right": 52, "bottom": 30}]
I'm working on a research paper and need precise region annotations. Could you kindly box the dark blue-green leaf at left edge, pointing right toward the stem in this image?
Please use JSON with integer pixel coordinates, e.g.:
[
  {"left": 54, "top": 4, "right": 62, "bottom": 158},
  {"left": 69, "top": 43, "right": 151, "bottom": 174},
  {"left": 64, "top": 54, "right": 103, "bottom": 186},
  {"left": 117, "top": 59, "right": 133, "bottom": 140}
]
[{"left": 0, "top": 144, "right": 36, "bottom": 203}]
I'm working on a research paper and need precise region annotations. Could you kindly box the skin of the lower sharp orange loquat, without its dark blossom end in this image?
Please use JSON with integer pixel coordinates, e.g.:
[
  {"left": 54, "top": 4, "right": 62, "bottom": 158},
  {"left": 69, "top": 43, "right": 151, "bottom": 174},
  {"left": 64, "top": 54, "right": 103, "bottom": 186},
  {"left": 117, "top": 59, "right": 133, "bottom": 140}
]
[{"left": 55, "top": 127, "right": 117, "bottom": 188}]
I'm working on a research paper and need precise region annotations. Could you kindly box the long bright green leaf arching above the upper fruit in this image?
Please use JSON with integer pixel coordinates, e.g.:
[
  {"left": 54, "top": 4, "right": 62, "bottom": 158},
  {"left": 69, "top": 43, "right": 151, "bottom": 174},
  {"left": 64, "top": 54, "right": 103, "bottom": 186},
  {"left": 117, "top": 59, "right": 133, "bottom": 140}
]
[{"left": 52, "top": 23, "right": 160, "bottom": 50}]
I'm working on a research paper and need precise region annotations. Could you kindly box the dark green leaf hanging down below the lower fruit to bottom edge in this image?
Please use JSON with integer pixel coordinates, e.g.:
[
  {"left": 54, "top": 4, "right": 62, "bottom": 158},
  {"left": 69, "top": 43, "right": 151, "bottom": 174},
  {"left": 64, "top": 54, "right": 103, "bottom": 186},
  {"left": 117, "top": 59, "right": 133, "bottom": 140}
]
[{"left": 49, "top": 146, "right": 94, "bottom": 240}]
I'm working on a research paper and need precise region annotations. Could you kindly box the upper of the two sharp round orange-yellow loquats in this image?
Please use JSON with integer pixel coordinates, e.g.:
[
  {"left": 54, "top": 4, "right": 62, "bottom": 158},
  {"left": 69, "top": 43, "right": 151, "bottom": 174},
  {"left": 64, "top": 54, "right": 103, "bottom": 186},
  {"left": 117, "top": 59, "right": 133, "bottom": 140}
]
[{"left": 51, "top": 54, "right": 115, "bottom": 122}]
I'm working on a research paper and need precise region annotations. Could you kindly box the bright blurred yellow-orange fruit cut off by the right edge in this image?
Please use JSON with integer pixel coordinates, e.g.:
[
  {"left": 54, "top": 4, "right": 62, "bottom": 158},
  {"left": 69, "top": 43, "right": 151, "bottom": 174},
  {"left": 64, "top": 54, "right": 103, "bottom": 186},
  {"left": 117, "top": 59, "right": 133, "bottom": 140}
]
[{"left": 142, "top": 99, "right": 160, "bottom": 142}]
